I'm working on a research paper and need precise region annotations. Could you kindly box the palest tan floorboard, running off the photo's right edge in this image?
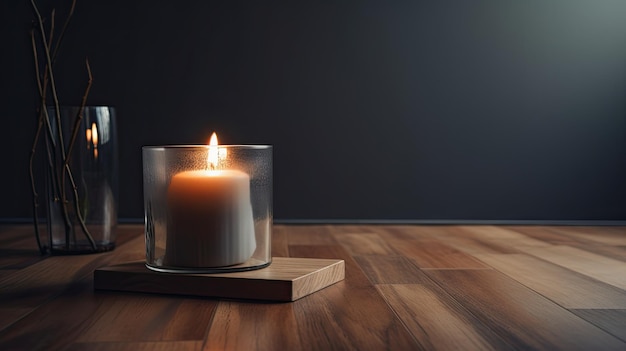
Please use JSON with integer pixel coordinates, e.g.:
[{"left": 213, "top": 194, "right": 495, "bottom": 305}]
[{"left": 523, "top": 246, "right": 626, "bottom": 290}]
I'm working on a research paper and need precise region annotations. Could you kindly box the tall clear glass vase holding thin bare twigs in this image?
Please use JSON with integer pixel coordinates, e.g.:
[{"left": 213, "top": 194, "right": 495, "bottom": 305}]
[{"left": 39, "top": 106, "right": 118, "bottom": 254}]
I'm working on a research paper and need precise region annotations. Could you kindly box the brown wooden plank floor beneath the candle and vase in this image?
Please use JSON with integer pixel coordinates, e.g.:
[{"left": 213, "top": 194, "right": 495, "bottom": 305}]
[{"left": 0, "top": 225, "right": 626, "bottom": 350}]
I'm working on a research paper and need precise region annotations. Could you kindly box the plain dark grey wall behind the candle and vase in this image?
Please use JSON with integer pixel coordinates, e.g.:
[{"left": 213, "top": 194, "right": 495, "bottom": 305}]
[{"left": 0, "top": 0, "right": 626, "bottom": 220}]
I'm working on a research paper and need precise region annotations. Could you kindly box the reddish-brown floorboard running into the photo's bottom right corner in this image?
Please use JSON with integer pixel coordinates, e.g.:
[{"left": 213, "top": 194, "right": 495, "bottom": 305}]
[{"left": 426, "top": 270, "right": 626, "bottom": 350}]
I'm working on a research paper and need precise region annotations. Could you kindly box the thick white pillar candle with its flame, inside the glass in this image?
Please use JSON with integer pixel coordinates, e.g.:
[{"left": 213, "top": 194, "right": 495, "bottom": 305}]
[{"left": 164, "top": 133, "right": 256, "bottom": 268}]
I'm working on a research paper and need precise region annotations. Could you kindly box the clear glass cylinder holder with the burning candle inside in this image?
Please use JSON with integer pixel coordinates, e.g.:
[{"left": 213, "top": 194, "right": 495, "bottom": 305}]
[{"left": 143, "top": 145, "right": 272, "bottom": 273}]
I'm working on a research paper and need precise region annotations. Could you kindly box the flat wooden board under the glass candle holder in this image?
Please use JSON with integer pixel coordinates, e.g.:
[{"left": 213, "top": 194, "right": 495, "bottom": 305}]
[{"left": 94, "top": 257, "right": 345, "bottom": 301}]
